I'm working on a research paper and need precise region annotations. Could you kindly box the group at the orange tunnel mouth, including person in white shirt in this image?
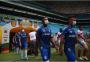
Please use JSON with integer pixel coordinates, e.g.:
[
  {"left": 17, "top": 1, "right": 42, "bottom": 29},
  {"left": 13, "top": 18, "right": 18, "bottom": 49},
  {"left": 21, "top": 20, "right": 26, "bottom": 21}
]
[{"left": 13, "top": 29, "right": 38, "bottom": 60}]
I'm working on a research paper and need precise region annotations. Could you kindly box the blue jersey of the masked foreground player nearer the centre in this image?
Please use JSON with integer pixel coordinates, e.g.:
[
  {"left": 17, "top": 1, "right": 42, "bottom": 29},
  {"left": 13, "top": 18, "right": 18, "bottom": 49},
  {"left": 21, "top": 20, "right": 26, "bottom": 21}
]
[{"left": 37, "top": 26, "right": 51, "bottom": 48}]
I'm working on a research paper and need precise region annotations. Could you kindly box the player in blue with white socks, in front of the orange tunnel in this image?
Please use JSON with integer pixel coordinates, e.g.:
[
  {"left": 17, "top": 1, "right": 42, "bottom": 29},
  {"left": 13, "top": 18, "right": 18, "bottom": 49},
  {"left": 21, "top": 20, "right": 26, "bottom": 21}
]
[{"left": 20, "top": 29, "right": 28, "bottom": 60}]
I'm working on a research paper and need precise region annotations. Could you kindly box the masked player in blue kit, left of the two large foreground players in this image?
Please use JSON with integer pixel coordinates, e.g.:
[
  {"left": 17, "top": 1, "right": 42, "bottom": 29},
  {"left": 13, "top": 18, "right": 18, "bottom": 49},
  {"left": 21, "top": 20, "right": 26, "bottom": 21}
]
[{"left": 36, "top": 17, "right": 55, "bottom": 62}]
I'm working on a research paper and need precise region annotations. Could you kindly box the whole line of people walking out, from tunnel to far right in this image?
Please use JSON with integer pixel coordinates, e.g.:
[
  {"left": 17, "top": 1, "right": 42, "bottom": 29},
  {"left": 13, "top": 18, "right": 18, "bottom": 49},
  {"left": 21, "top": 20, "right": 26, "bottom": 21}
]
[{"left": 11, "top": 16, "right": 88, "bottom": 62}]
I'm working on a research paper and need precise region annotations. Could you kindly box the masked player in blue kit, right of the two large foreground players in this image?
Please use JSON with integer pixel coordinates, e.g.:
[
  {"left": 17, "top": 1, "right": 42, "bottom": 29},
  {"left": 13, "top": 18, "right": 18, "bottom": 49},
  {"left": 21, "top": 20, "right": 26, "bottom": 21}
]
[{"left": 63, "top": 16, "right": 77, "bottom": 62}]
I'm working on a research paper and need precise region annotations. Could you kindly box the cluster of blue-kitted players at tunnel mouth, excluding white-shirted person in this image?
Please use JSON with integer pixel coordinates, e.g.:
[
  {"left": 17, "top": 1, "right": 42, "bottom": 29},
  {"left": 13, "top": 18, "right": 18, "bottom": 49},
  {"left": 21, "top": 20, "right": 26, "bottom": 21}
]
[{"left": 14, "top": 29, "right": 28, "bottom": 60}]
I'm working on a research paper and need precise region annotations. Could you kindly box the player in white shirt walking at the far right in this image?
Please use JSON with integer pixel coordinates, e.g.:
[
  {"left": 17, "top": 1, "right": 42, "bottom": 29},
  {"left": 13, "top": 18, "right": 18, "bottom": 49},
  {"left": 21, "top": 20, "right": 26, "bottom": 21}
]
[{"left": 77, "top": 26, "right": 88, "bottom": 60}]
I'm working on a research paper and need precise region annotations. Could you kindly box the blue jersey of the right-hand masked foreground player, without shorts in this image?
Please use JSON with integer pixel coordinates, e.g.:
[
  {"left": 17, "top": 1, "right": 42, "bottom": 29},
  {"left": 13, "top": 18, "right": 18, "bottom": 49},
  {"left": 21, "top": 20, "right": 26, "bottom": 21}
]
[{"left": 63, "top": 27, "right": 76, "bottom": 48}]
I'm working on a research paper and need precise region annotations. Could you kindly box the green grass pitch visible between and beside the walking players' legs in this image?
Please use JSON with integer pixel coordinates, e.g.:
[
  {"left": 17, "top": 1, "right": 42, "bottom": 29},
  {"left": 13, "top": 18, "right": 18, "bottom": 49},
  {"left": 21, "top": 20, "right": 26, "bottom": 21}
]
[{"left": 0, "top": 45, "right": 90, "bottom": 62}]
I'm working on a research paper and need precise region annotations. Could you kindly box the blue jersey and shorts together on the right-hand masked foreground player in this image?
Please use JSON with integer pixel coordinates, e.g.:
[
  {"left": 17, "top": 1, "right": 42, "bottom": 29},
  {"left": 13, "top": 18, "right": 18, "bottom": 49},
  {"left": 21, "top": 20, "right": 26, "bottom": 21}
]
[{"left": 63, "top": 27, "right": 76, "bottom": 62}]
